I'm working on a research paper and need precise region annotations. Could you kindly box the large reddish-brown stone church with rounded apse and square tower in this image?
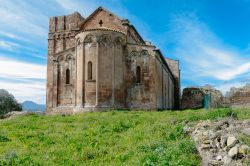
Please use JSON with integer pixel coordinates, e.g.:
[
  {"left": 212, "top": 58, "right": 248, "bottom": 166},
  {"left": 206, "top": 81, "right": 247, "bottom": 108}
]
[{"left": 46, "top": 7, "right": 180, "bottom": 113}]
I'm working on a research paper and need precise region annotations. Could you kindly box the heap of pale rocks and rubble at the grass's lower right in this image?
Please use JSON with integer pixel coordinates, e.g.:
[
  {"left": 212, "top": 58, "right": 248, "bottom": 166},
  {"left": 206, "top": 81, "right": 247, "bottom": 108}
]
[{"left": 184, "top": 118, "right": 250, "bottom": 166}]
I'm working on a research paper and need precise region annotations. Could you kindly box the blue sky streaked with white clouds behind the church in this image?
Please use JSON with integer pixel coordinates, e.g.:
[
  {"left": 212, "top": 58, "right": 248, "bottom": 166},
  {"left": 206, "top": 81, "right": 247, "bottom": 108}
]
[{"left": 0, "top": 0, "right": 250, "bottom": 103}]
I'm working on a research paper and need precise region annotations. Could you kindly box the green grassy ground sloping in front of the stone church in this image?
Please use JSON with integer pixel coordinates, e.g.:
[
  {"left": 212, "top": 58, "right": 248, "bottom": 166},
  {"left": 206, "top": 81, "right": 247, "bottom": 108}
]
[{"left": 0, "top": 109, "right": 250, "bottom": 166}]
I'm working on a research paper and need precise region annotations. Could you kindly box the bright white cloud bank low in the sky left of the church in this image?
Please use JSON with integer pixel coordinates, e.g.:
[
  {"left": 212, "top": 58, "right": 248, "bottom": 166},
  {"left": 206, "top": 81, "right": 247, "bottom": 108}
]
[{"left": 0, "top": 57, "right": 46, "bottom": 103}]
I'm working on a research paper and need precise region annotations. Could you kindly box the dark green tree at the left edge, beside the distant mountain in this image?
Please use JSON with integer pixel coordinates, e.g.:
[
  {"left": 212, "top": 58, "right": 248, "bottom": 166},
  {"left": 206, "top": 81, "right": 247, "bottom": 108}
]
[{"left": 0, "top": 89, "right": 22, "bottom": 117}]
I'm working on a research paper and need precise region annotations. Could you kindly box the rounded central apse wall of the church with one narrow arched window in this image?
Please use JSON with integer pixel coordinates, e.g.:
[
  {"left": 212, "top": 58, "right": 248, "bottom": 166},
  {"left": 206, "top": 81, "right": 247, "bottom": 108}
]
[{"left": 76, "top": 29, "right": 125, "bottom": 107}]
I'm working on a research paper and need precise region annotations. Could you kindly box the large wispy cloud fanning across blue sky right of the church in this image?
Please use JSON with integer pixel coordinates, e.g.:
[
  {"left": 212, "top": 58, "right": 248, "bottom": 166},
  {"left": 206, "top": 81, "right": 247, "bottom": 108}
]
[{"left": 169, "top": 14, "right": 250, "bottom": 83}]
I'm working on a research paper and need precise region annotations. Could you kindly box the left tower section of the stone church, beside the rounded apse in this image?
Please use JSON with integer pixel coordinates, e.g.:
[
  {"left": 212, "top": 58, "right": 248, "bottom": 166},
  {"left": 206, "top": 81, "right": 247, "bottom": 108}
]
[{"left": 46, "top": 12, "right": 84, "bottom": 110}]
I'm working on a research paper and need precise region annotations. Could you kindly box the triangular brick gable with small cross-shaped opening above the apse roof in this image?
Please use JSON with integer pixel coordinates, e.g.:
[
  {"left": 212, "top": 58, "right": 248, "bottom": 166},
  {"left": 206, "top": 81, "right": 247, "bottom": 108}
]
[{"left": 81, "top": 8, "right": 127, "bottom": 33}]
